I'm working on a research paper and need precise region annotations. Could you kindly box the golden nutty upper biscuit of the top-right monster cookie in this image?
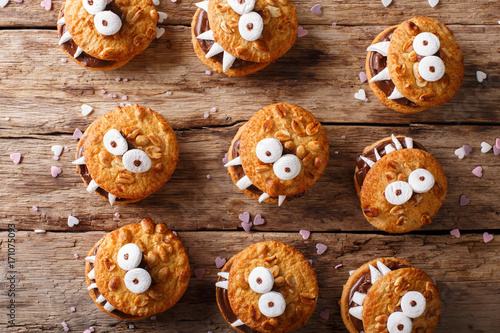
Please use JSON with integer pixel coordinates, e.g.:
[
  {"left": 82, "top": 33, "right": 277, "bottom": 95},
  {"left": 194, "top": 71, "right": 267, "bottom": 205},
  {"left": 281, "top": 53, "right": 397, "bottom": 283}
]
[{"left": 387, "top": 17, "right": 464, "bottom": 108}]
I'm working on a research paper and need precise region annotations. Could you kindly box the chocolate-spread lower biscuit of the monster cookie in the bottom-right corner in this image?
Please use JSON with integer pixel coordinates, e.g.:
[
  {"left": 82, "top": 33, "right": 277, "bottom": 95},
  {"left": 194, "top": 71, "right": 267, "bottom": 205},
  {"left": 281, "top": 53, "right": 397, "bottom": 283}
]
[{"left": 339, "top": 257, "right": 412, "bottom": 333}]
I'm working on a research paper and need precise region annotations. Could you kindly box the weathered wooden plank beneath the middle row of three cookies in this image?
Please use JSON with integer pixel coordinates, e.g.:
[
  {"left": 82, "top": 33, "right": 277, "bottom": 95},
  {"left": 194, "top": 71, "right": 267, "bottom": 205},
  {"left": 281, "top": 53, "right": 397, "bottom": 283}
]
[{"left": 0, "top": 124, "right": 500, "bottom": 231}]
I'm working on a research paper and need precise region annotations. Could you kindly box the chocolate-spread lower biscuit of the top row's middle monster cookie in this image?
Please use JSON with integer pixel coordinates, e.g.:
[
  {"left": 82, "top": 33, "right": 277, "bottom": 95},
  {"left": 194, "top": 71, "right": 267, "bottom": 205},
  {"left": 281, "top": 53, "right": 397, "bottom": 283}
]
[{"left": 191, "top": 8, "right": 271, "bottom": 76}]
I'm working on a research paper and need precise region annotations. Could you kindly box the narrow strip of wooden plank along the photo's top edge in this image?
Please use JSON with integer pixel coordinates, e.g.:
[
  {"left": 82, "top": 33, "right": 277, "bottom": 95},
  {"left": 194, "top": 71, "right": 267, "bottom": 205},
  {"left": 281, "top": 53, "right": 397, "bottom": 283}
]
[{"left": 0, "top": 0, "right": 498, "bottom": 27}]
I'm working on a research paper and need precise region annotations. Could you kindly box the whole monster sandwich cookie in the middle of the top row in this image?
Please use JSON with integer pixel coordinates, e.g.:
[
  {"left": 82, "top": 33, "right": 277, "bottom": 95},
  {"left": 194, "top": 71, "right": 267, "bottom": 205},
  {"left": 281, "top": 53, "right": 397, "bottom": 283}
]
[{"left": 191, "top": 0, "right": 298, "bottom": 76}]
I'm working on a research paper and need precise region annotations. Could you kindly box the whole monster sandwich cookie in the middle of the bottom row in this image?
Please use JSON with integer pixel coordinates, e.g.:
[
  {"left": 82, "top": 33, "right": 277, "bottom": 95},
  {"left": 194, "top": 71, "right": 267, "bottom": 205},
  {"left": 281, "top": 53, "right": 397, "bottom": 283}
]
[{"left": 216, "top": 241, "right": 318, "bottom": 333}]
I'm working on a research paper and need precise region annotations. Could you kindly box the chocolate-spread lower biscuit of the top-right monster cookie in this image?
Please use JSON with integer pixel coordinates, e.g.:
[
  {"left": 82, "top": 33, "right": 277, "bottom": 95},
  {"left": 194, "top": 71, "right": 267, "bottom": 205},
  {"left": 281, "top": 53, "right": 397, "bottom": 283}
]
[{"left": 365, "top": 25, "right": 426, "bottom": 113}]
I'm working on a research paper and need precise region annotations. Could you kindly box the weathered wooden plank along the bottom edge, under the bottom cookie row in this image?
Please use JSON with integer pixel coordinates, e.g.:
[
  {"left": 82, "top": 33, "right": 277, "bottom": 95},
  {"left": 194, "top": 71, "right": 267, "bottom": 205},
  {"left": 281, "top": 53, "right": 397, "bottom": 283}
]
[{"left": 0, "top": 231, "right": 500, "bottom": 333}]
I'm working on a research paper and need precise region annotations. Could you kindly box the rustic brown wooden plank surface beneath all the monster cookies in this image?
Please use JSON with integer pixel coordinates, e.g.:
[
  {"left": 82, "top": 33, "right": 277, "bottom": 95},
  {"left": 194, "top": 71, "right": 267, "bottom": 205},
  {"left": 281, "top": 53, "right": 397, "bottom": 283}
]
[{"left": 0, "top": 0, "right": 500, "bottom": 333}]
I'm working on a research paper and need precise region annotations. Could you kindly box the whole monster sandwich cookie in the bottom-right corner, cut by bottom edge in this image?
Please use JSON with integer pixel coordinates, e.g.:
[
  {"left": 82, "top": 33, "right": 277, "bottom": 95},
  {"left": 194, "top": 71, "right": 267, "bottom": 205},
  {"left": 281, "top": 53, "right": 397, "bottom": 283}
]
[{"left": 340, "top": 258, "right": 441, "bottom": 333}]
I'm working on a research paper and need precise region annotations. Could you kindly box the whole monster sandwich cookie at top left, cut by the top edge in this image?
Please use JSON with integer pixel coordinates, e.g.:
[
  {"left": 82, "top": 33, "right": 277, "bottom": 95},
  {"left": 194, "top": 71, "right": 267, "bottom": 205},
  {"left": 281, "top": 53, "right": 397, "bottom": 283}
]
[{"left": 57, "top": 0, "right": 159, "bottom": 71}]
